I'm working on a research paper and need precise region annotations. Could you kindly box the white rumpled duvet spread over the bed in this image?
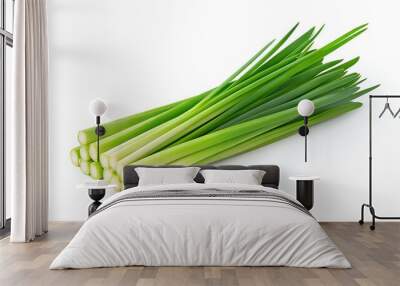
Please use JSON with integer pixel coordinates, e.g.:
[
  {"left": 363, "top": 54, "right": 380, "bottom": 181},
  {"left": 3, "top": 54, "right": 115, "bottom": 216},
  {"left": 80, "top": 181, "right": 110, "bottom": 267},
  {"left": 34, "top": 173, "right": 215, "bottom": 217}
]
[{"left": 50, "top": 184, "right": 350, "bottom": 269}]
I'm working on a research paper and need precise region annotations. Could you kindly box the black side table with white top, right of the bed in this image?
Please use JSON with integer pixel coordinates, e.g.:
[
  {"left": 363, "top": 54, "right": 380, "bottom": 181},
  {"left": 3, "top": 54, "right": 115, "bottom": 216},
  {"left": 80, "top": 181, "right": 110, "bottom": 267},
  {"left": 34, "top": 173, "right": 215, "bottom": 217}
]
[{"left": 289, "top": 176, "right": 319, "bottom": 210}]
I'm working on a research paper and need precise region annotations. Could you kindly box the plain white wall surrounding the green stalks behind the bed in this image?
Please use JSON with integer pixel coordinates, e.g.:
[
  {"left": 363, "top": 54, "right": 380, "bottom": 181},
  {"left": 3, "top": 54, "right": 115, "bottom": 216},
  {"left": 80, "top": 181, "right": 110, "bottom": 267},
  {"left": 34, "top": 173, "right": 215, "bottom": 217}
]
[{"left": 48, "top": 0, "right": 400, "bottom": 221}]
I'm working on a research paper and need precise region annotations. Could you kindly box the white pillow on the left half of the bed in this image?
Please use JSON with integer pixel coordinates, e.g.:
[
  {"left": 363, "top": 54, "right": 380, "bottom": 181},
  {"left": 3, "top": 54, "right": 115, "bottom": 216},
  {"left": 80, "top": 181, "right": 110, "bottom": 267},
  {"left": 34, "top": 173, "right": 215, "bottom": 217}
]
[{"left": 135, "top": 167, "right": 200, "bottom": 186}]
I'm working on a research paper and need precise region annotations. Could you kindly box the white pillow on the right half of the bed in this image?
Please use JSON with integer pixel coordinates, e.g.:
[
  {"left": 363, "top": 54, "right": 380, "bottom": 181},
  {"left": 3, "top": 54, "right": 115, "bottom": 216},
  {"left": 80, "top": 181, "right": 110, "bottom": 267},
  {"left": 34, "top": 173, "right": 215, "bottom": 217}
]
[{"left": 200, "top": 170, "right": 265, "bottom": 185}]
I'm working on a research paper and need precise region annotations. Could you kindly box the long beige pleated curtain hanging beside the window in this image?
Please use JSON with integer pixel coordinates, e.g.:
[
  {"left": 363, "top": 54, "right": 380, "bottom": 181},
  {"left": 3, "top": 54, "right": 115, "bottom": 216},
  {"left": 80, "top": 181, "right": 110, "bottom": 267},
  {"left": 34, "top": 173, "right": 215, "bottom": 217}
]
[{"left": 7, "top": 0, "right": 48, "bottom": 242}]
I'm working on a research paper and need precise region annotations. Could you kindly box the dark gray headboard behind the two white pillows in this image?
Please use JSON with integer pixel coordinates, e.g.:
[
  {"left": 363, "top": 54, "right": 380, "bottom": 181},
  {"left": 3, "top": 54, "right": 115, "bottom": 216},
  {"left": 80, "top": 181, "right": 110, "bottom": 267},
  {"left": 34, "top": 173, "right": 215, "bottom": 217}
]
[{"left": 124, "top": 165, "right": 279, "bottom": 189}]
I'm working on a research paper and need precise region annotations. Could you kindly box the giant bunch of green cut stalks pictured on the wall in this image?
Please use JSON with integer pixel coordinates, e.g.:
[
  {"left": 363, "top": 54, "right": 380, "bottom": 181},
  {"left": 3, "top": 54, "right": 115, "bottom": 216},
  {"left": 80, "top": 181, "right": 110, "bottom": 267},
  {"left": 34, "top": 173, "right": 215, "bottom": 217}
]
[{"left": 70, "top": 24, "right": 378, "bottom": 188}]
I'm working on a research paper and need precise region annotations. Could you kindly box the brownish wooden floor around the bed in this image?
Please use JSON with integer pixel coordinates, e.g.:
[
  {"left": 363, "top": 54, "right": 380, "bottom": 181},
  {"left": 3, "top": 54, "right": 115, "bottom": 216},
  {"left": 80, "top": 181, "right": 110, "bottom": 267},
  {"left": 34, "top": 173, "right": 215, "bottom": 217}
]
[{"left": 0, "top": 222, "right": 400, "bottom": 286}]
